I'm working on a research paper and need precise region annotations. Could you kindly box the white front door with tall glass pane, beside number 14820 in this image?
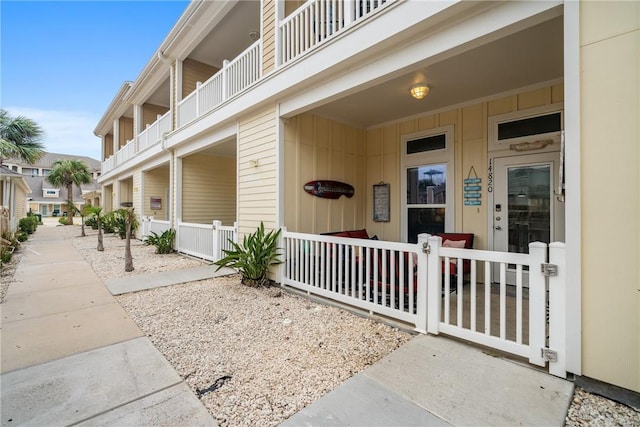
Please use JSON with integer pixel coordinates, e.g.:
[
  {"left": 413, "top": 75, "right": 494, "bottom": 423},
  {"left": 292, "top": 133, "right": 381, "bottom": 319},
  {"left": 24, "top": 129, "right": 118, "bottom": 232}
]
[{"left": 491, "top": 152, "right": 564, "bottom": 286}]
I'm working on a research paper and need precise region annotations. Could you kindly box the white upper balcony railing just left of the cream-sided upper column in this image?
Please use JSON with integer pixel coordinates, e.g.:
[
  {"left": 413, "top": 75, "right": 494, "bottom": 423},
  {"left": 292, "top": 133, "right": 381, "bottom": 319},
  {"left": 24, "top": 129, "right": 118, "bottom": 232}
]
[{"left": 178, "top": 40, "right": 262, "bottom": 127}]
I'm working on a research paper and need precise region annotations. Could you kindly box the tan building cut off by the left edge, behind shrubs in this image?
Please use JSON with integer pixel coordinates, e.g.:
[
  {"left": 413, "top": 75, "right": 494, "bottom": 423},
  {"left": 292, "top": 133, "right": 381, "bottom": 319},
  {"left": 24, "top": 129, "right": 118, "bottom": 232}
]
[{"left": 0, "top": 165, "right": 31, "bottom": 235}]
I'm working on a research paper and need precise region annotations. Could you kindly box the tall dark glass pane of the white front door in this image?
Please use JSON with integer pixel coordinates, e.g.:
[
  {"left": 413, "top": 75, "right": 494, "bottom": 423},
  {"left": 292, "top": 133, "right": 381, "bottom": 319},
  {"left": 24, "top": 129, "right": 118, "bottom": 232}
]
[{"left": 507, "top": 165, "right": 551, "bottom": 253}]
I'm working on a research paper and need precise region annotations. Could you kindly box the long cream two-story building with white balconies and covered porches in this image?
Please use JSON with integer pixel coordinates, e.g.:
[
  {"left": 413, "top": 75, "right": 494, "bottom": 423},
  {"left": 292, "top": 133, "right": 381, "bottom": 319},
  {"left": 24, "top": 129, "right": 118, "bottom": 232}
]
[{"left": 95, "top": 0, "right": 640, "bottom": 398}]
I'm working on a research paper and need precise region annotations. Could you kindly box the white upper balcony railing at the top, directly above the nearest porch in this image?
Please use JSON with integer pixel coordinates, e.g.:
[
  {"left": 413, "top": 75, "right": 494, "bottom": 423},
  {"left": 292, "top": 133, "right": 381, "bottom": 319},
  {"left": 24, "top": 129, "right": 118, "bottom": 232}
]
[{"left": 279, "top": 0, "right": 395, "bottom": 64}]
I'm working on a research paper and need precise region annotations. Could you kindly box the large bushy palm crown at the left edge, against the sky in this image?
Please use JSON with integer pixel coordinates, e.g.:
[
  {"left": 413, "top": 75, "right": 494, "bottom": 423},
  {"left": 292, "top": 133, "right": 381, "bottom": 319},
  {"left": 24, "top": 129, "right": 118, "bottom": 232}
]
[{"left": 0, "top": 109, "right": 45, "bottom": 166}]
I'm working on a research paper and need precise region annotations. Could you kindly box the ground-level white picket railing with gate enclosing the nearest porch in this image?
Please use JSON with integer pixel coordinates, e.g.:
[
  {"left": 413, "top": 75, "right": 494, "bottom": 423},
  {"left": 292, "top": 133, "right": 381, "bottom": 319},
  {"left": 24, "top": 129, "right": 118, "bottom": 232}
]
[{"left": 280, "top": 228, "right": 566, "bottom": 378}]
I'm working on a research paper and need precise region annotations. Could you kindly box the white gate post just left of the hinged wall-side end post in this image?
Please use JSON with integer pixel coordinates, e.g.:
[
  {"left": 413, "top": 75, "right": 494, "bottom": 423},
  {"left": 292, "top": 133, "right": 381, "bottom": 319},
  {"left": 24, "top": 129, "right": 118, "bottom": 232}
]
[{"left": 529, "top": 242, "right": 547, "bottom": 366}]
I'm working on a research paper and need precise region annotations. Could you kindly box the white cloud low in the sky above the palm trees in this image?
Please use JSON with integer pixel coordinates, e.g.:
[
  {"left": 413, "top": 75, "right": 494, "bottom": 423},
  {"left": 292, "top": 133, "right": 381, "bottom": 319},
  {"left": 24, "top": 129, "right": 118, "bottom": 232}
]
[{"left": 3, "top": 107, "right": 101, "bottom": 160}]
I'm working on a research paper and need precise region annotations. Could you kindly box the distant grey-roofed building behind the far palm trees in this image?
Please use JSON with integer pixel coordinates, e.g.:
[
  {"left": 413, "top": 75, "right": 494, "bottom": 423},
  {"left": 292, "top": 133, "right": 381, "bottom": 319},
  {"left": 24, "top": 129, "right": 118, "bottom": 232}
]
[{"left": 3, "top": 153, "right": 101, "bottom": 216}]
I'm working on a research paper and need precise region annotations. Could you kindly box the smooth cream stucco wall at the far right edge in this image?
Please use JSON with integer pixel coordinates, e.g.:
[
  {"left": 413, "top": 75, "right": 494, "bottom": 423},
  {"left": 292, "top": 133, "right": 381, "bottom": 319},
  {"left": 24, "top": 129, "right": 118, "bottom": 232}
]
[{"left": 580, "top": 2, "right": 640, "bottom": 391}]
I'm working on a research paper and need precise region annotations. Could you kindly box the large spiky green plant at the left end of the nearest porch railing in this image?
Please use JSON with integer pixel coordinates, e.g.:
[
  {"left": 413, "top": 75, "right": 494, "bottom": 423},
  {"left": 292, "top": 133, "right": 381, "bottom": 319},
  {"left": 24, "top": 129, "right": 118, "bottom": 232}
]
[{"left": 215, "top": 222, "right": 282, "bottom": 286}]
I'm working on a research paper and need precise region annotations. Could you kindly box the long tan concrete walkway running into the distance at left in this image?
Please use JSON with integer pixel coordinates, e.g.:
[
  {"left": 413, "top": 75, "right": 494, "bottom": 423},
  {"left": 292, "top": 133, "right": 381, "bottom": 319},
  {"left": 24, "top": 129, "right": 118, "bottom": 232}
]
[{"left": 0, "top": 226, "right": 216, "bottom": 426}]
